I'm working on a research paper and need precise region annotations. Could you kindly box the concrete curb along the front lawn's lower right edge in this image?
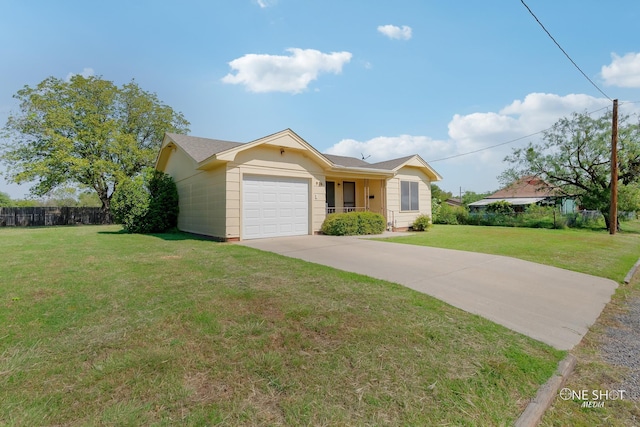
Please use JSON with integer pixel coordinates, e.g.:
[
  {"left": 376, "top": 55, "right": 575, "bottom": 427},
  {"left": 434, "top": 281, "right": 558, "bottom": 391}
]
[{"left": 514, "top": 354, "right": 577, "bottom": 427}]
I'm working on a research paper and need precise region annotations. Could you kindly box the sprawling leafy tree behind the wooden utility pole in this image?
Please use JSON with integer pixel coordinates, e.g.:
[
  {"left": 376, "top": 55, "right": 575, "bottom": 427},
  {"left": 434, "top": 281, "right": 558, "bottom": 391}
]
[{"left": 500, "top": 113, "right": 640, "bottom": 228}]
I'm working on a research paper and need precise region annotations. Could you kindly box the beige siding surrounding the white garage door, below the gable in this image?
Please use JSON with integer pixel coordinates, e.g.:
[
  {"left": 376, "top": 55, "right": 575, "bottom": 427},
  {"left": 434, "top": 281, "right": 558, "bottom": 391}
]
[{"left": 226, "top": 145, "right": 325, "bottom": 238}]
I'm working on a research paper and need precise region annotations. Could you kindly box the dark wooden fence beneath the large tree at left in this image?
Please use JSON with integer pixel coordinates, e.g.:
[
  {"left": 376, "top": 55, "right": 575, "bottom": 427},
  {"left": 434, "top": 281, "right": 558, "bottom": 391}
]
[{"left": 0, "top": 207, "right": 109, "bottom": 227}]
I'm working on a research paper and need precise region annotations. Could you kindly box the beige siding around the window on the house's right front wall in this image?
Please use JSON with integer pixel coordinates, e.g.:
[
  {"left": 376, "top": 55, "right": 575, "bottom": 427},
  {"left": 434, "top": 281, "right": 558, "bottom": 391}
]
[{"left": 387, "top": 167, "right": 431, "bottom": 228}]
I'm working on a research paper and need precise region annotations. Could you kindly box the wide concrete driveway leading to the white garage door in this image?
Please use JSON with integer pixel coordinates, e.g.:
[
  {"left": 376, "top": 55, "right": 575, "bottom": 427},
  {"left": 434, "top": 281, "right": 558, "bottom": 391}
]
[{"left": 239, "top": 236, "right": 617, "bottom": 350}]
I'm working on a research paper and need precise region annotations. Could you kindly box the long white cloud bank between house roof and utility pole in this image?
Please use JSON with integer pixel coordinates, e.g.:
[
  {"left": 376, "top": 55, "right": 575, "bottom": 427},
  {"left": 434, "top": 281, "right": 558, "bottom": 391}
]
[{"left": 325, "top": 93, "right": 611, "bottom": 192}]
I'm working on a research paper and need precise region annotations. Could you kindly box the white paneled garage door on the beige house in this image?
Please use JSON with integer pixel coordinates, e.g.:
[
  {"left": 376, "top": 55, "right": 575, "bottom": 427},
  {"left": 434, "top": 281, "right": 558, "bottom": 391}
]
[{"left": 242, "top": 176, "right": 309, "bottom": 239}]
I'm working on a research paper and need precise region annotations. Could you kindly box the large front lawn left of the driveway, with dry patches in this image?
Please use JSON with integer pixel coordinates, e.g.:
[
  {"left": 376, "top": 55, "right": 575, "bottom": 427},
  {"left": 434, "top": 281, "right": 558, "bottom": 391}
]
[{"left": 0, "top": 226, "right": 564, "bottom": 426}]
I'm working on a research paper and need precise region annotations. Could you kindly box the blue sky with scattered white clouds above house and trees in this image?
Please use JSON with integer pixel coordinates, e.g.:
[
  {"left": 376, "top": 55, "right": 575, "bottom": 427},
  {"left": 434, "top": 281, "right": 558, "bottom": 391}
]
[{"left": 0, "top": 0, "right": 640, "bottom": 198}]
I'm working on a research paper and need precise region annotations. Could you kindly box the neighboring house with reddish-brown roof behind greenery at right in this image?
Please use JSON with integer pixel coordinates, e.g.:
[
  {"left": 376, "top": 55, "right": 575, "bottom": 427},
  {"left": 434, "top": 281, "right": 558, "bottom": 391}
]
[{"left": 469, "top": 176, "right": 576, "bottom": 214}]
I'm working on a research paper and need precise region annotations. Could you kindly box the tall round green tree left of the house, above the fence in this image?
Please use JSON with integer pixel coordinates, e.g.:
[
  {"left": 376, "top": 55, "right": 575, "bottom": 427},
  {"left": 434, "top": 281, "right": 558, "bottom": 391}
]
[{"left": 0, "top": 75, "right": 189, "bottom": 221}]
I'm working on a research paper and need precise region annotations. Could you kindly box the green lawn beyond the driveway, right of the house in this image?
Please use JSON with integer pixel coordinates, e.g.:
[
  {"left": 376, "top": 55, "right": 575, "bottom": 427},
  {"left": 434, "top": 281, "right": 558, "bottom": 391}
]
[{"left": 385, "top": 222, "right": 640, "bottom": 282}]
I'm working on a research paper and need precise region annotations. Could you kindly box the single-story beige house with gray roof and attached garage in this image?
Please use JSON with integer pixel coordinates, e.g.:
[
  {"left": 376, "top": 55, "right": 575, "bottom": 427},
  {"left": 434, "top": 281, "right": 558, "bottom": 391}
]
[{"left": 156, "top": 129, "right": 442, "bottom": 240}]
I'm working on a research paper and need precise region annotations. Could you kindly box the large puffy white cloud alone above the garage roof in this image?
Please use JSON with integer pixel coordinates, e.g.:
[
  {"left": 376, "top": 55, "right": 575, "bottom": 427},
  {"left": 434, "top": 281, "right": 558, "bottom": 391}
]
[{"left": 222, "top": 48, "right": 352, "bottom": 93}]
